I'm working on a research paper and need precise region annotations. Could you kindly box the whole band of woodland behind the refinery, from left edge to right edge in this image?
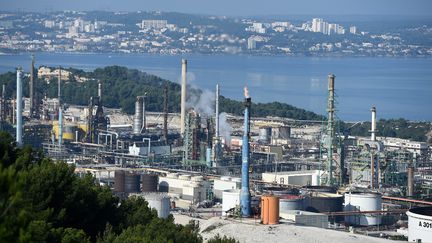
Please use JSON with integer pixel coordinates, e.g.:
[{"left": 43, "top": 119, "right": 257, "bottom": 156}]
[{"left": 0, "top": 66, "right": 432, "bottom": 142}]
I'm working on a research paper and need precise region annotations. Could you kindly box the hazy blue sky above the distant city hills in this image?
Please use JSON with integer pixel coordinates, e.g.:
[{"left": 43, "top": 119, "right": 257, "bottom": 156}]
[{"left": 0, "top": 0, "right": 432, "bottom": 16}]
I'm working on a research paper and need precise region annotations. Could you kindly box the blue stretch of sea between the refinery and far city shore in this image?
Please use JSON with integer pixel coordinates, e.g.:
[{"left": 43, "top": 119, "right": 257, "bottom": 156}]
[{"left": 0, "top": 53, "right": 432, "bottom": 121}]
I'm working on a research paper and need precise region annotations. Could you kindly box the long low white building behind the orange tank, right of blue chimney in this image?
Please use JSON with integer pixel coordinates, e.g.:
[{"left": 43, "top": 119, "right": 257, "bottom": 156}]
[{"left": 262, "top": 170, "right": 324, "bottom": 186}]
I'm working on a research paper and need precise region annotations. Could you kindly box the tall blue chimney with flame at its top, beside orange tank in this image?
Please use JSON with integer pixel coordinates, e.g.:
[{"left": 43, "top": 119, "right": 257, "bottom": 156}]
[{"left": 240, "top": 87, "right": 251, "bottom": 217}]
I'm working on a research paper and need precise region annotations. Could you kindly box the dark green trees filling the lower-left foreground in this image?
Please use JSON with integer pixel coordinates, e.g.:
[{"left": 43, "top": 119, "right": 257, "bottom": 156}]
[{"left": 0, "top": 132, "right": 236, "bottom": 243}]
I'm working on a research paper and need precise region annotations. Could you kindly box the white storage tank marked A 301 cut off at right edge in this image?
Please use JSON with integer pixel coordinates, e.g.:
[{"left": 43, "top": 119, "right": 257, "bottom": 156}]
[{"left": 406, "top": 207, "right": 432, "bottom": 242}]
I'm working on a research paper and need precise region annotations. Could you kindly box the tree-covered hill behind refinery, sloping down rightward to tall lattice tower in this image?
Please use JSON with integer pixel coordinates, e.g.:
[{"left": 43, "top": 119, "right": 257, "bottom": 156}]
[{"left": 0, "top": 66, "right": 324, "bottom": 120}]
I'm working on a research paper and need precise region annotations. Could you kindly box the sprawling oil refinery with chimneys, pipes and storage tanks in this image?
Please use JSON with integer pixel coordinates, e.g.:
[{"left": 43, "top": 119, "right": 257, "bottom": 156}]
[{"left": 0, "top": 59, "right": 432, "bottom": 242}]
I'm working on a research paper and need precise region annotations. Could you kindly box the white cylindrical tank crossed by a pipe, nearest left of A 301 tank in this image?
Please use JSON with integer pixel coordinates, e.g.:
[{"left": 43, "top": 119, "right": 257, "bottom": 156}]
[{"left": 344, "top": 192, "right": 382, "bottom": 226}]
